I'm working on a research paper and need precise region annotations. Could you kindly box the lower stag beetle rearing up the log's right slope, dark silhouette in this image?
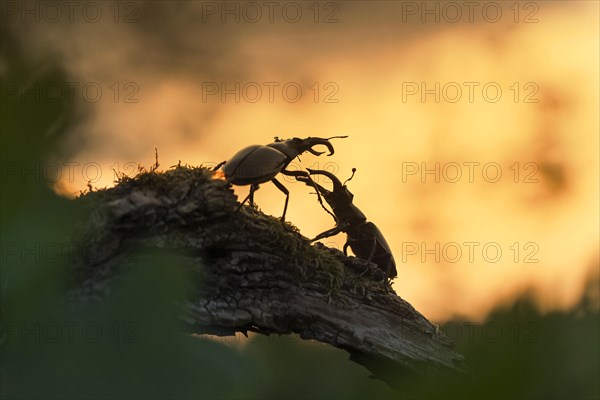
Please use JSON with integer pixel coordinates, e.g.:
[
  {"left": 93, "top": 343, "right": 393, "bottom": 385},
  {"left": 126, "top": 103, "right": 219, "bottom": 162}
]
[{"left": 296, "top": 168, "right": 398, "bottom": 279}]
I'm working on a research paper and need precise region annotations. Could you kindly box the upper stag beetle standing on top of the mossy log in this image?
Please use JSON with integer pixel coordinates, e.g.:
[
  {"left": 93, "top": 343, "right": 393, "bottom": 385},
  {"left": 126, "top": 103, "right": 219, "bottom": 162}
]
[{"left": 213, "top": 136, "right": 348, "bottom": 221}]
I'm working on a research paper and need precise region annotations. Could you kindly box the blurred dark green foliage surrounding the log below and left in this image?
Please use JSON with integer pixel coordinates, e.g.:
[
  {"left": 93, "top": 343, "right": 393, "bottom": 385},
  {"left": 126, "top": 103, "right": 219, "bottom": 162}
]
[{"left": 0, "top": 25, "right": 600, "bottom": 399}]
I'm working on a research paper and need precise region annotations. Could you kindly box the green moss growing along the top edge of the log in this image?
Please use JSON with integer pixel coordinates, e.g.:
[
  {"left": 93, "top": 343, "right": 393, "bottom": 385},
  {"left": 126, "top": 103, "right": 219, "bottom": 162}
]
[{"left": 78, "top": 165, "right": 384, "bottom": 294}]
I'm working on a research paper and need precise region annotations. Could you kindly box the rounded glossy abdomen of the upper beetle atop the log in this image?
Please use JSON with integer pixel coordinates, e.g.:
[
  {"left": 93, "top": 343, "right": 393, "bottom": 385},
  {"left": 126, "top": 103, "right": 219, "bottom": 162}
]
[{"left": 223, "top": 144, "right": 287, "bottom": 185}]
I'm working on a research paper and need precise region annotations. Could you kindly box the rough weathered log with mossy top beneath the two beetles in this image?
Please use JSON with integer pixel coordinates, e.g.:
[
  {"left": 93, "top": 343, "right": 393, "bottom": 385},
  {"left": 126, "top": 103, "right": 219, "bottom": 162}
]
[{"left": 69, "top": 167, "right": 464, "bottom": 383}]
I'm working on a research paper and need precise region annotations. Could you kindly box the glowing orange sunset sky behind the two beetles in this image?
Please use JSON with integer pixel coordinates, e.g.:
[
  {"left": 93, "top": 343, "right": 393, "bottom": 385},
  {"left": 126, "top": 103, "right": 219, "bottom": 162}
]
[{"left": 11, "top": 1, "right": 600, "bottom": 321}]
